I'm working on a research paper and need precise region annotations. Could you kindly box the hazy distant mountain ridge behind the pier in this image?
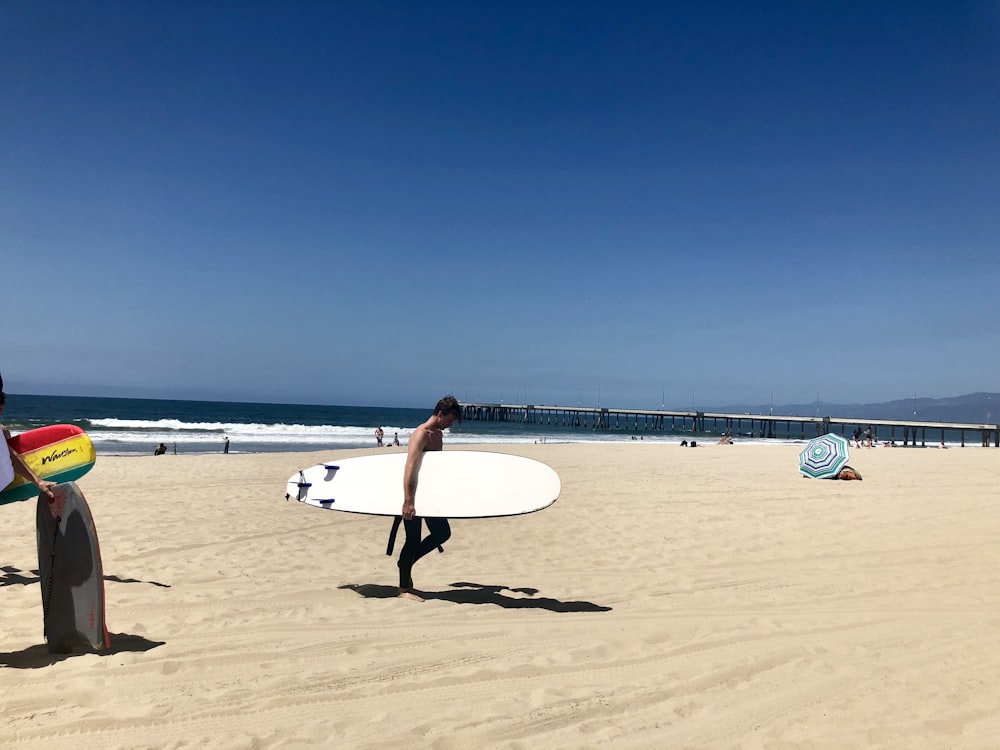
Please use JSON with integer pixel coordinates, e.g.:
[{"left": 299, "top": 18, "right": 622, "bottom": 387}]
[{"left": 716, "top": 393, "right": 1000, "bottom": 424}]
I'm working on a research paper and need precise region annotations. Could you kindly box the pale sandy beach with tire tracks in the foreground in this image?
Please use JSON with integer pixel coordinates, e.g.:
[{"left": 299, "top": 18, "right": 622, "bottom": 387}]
[{"left": 0, "top": 442, "right": 1000, "bottom": 750}]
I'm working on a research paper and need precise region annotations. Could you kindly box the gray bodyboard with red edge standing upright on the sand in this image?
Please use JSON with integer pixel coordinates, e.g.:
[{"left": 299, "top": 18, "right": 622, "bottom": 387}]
[{"left": 35, "top": 482, "right": 110, "bottom": 653}]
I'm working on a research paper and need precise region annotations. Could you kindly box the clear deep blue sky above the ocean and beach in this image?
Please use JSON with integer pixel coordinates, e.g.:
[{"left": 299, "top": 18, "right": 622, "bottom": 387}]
[{"left": 0, "top": 0, "right": 1000, "bottom": 408}]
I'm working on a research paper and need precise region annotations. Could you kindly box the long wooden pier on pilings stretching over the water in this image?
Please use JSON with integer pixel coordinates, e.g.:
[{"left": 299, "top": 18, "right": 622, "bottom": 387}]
[{"left": 462, "top": 403, "right": 1000, "bottom": 447}]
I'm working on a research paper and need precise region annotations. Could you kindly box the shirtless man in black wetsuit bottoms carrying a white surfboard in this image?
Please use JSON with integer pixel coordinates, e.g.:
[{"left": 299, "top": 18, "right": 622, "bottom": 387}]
[{"left": 396, "top": 396, "right": 462, "bottom": 602}]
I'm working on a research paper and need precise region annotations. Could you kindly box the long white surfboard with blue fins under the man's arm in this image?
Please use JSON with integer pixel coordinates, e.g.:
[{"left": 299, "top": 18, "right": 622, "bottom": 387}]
[{"left": 286, "top": 451, "right": 562, "bottom": 518}]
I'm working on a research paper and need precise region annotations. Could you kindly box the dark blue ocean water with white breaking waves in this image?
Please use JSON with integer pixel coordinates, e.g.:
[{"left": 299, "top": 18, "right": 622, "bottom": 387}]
[{"left": 0, "top": 394, "right": 784, "bottom": 455}]
